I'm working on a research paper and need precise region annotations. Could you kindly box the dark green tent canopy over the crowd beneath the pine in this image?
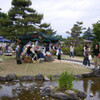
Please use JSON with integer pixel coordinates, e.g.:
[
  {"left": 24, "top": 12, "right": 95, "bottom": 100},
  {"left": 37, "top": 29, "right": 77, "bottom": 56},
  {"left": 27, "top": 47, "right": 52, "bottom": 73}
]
[{"left": 17, "top": 33, "right": 60, "bottom": 45}]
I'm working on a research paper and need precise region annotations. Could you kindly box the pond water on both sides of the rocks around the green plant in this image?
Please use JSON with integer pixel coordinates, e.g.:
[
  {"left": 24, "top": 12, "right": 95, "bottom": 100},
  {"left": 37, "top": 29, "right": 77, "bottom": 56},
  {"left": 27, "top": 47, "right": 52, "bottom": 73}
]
[{"left": 0, "top": 78, "right": 100, "bottom": 100}]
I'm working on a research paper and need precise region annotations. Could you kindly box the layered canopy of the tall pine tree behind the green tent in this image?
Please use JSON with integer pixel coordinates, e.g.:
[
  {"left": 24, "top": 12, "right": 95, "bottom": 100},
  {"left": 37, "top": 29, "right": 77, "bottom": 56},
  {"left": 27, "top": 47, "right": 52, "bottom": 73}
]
[{"left": 3, "top": 0, "right": 55, "bottom": 37}]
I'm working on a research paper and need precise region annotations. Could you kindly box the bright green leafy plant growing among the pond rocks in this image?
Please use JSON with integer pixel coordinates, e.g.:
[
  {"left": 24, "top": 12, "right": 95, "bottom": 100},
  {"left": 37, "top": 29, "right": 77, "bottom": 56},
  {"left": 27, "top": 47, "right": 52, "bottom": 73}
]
[{"left": 58, "top": 72, "right": 74, "bottom": 89}]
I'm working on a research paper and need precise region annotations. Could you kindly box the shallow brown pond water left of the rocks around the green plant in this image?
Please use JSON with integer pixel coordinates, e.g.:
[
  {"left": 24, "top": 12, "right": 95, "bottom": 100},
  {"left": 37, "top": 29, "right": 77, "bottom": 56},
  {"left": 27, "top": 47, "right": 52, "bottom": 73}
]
[{"left": 0, "top": 82, "right": 57, "bottom": 100}]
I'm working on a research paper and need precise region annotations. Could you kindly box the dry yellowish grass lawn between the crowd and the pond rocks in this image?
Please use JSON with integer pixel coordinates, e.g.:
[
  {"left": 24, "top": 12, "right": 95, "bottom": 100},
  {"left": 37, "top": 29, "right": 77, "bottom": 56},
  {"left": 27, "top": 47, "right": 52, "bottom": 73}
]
[{"left": 0, "top": 56, "right": 91, "bottom": 76}]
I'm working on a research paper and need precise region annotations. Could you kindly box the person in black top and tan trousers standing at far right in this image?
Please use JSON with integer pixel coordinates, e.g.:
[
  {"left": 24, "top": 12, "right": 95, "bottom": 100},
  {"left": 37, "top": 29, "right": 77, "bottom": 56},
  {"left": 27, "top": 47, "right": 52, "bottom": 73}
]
[{"left": 93, "top": 44, "right": 99, "bottom": 68}]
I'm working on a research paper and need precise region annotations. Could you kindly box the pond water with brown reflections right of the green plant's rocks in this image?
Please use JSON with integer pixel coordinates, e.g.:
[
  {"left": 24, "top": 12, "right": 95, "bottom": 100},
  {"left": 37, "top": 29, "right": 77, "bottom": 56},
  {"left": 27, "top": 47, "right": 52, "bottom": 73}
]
[{"left": 74, "top": 78, "right": 100, "bottom": 100}]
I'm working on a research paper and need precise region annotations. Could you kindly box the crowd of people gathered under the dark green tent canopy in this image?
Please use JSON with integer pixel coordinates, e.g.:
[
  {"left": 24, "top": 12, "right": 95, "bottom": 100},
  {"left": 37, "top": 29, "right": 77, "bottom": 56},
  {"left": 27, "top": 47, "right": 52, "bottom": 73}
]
[{"left": 16, "top": 41, "right": 62, "bottom": 61}]
